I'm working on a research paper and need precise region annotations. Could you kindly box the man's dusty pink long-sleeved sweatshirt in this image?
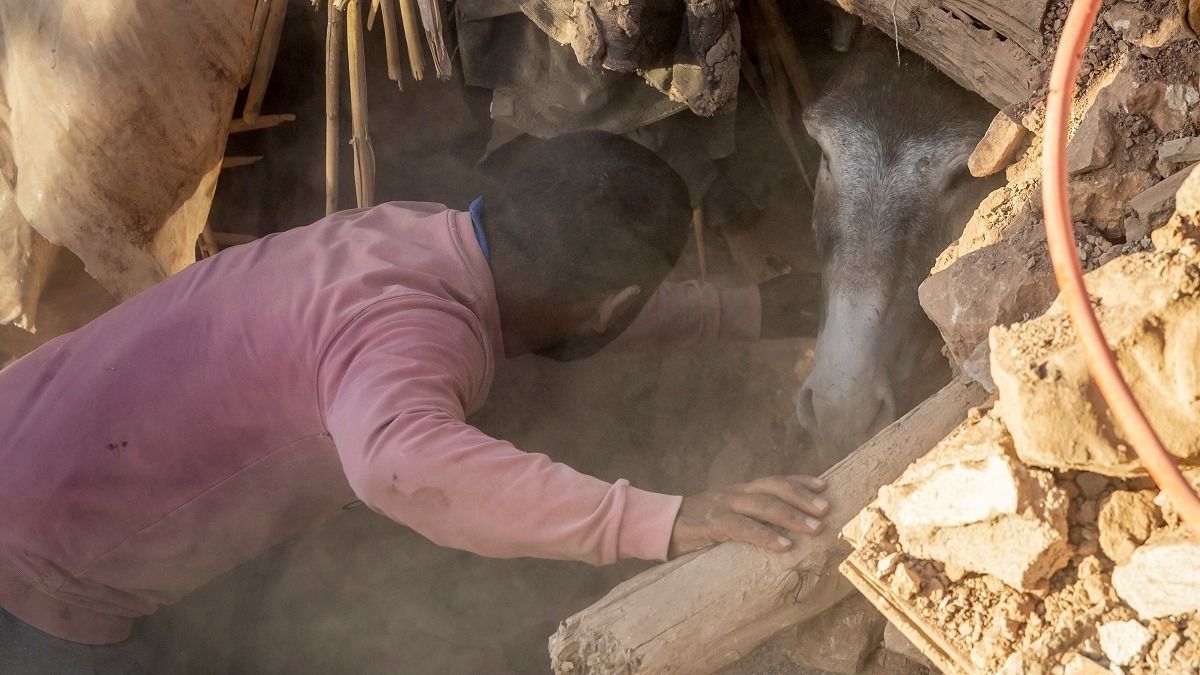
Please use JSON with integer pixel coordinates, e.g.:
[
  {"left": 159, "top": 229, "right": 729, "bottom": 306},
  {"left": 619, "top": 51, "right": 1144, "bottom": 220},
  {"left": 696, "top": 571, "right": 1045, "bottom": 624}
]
[{"left": 0, "top": 203, "right": 760, "bottom": 644}]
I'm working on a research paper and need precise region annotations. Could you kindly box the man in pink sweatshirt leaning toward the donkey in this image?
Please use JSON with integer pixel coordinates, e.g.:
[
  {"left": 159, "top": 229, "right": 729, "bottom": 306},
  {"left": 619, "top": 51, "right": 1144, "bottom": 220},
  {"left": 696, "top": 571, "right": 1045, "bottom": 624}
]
[{"left": 0, "top": 133, "right": 828, "bottom": 673}]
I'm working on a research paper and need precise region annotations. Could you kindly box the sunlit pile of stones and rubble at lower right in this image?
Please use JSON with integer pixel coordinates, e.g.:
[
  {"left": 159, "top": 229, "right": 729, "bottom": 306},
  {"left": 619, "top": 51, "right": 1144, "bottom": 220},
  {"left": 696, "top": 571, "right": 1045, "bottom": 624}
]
[{"left": 842, "top": 216, "right": 1200, "bottom": 674}]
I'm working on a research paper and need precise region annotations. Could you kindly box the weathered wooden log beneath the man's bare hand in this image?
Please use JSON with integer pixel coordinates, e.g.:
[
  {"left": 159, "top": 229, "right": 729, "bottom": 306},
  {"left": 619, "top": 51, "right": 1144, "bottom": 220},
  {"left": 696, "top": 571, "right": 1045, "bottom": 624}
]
[{"left": 550, "top": 378, "right": 988, "bottom": 675}]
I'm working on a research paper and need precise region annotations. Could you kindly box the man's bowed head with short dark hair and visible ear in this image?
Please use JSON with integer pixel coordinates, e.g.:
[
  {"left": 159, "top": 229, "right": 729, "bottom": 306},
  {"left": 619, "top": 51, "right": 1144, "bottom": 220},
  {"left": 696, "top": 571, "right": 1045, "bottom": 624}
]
[{"left": 485, "top": 132, "right": 691, "bottom": 359}]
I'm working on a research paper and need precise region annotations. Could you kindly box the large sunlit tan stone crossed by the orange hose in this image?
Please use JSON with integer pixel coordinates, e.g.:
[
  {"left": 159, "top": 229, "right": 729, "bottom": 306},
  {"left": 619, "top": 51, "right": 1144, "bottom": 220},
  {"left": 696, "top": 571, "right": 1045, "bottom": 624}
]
[{"left": 990, "top": 239, "right": 1200, "bottom": 477}]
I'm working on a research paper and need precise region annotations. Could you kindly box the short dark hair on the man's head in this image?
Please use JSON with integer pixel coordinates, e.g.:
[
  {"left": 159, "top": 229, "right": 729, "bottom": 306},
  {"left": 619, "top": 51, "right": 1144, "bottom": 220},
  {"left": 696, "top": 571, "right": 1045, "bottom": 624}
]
[{"left": 485, "top": 131, "right": 691, "bottom": 305}]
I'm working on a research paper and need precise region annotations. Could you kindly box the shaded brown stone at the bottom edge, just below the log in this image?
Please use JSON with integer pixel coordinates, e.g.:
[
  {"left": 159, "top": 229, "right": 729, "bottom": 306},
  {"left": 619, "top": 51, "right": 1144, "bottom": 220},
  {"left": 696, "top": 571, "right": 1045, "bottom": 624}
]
[{"left": 782, "top": 595, "right": 887, "bottom": 675}]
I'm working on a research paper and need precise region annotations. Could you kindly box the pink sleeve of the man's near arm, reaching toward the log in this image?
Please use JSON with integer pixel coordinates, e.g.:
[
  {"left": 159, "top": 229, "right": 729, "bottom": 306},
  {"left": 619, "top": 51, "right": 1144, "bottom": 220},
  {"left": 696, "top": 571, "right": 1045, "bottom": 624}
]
[{"left": 318, "top": 295, "right": 682, "bottom": 565}]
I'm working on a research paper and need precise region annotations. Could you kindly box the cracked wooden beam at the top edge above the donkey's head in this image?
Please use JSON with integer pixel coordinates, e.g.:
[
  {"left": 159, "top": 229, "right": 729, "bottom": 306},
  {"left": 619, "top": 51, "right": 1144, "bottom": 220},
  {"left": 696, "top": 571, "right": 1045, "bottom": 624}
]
[{"left": 828, "top": 0, "right": 1049, "bottom": 108}]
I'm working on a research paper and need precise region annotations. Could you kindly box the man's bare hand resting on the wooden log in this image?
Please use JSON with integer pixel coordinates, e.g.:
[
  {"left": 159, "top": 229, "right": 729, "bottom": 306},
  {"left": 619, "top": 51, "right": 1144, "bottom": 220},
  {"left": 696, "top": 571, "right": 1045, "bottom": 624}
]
[{"left": 667, "top": 476, "right": 829, "bottom": 558}]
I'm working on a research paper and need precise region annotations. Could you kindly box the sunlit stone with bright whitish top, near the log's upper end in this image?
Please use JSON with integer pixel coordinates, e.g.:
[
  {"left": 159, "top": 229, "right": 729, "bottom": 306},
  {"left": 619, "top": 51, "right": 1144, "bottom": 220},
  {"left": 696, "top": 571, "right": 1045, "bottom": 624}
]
[{"left": 876, "top": 414, "right": 1070, "bottom": 590}]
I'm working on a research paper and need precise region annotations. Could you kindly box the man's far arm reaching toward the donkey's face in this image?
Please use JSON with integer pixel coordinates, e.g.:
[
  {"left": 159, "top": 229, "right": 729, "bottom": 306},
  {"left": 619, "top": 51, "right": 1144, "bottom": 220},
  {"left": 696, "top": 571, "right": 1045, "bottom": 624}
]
[{"left": 606, "top": 273, "right": 821, "bottom": 352}]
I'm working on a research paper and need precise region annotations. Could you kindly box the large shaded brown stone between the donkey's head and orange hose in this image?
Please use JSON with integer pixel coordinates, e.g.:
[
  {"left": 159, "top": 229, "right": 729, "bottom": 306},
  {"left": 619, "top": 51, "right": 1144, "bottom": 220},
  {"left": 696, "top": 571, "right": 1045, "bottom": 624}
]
[{"left": 918, "top": 211, "right": 1058, "bottom": 365}]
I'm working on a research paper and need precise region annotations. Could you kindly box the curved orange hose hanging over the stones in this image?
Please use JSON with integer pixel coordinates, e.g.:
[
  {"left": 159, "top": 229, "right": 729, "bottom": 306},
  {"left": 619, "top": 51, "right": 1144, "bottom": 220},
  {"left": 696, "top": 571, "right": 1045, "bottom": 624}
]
[{"left": 1042, "top": 0, "right": 1200, "bottom": 537}]
